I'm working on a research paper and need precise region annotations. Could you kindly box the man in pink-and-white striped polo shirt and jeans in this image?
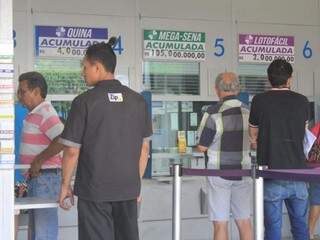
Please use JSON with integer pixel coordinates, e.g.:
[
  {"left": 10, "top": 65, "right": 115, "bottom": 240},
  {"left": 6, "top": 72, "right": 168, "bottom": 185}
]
[{"left": 18, "top": 72, "right": 63, "bottom": 240}]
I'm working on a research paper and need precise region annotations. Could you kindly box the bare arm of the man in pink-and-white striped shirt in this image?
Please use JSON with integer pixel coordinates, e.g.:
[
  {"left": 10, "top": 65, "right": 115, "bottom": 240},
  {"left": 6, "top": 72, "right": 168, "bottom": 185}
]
[{"left": 29, "top": 136, "right": 63, "bottom": 177}]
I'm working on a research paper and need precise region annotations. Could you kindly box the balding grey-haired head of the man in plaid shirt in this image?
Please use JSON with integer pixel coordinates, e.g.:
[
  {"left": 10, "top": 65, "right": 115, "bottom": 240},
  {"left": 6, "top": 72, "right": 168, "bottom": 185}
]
[{"left": 216, "top": 72, "right": 240, "bottom": 95}]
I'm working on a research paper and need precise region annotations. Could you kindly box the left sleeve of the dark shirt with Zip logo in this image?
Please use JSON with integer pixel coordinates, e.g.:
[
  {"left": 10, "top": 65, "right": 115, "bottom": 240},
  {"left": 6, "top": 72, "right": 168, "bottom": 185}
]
[{"left": 60, "top": 98, "right": 86, "bottom": 148}]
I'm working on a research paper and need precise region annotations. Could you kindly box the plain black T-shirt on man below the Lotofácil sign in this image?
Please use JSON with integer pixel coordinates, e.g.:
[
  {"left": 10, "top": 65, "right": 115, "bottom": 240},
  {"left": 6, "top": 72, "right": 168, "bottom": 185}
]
[{"left": 250, "top": 90, "right": 309, "bottom": 169}]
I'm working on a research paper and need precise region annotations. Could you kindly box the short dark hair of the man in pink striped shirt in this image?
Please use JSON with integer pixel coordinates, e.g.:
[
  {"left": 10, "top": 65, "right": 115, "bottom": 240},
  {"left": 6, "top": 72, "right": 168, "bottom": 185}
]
[{"left": 19, "top": 72, "right": 48, "bottom": 98}]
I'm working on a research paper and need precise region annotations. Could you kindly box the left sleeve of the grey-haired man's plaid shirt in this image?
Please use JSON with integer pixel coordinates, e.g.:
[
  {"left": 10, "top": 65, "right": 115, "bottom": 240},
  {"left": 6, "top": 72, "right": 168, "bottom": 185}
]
[{"left": 198, "top": 113, "right": 217, "bottom": 147}]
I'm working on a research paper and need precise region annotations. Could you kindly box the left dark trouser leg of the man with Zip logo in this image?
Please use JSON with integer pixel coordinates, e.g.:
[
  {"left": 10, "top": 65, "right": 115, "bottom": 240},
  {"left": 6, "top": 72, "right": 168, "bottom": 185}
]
[{"left": 78, "top": 198, "right": 115, "bottom": 240}]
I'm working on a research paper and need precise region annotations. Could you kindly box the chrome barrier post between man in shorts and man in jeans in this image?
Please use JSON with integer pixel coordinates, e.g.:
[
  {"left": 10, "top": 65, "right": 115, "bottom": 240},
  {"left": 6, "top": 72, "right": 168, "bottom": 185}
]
[{"left": 250, "top": 151, "right": 264, "bottom": 240}]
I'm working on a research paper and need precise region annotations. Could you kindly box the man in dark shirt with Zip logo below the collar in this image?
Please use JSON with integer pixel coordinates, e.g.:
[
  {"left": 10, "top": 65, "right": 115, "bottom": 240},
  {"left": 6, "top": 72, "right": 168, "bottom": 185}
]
[{"left": 59, "top": 38, "right": 152, "bottom": 240}]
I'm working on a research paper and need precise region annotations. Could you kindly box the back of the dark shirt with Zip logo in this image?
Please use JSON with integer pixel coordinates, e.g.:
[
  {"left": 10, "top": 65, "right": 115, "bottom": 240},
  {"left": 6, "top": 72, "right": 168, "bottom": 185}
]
[{"left": 66, "top": 80, "right": 152, "bottom": 201}]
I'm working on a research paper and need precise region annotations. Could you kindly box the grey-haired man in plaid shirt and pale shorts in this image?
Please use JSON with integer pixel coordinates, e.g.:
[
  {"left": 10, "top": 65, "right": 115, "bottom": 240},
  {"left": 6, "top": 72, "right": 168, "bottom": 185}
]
[{"left": 198, "top": 72, "right": 252, "bottom": 240}]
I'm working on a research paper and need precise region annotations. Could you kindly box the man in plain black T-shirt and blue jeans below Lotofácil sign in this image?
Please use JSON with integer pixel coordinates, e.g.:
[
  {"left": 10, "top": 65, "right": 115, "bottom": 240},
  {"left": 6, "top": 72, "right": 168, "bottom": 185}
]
[{"left": 249, "top": 60, "right": 309, "bottom": 240}]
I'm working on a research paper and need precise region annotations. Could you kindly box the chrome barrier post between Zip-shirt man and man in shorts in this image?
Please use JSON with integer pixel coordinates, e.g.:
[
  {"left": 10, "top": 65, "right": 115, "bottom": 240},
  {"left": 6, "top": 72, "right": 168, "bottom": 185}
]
[{"left": 172, "top": 164, "right": 182, "bottom": 240}]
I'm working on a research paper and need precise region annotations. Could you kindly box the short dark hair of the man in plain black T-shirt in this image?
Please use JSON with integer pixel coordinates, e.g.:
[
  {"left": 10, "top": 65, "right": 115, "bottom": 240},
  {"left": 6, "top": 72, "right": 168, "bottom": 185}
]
[{"left": 268, "top": 59, "right": 293, "bottom": 87}]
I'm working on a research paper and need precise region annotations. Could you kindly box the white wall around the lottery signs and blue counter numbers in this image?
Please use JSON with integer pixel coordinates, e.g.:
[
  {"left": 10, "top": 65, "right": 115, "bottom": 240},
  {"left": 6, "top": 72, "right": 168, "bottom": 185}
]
[{"left": 14, "top": 0, "right": 320, "bottom": 100}]
